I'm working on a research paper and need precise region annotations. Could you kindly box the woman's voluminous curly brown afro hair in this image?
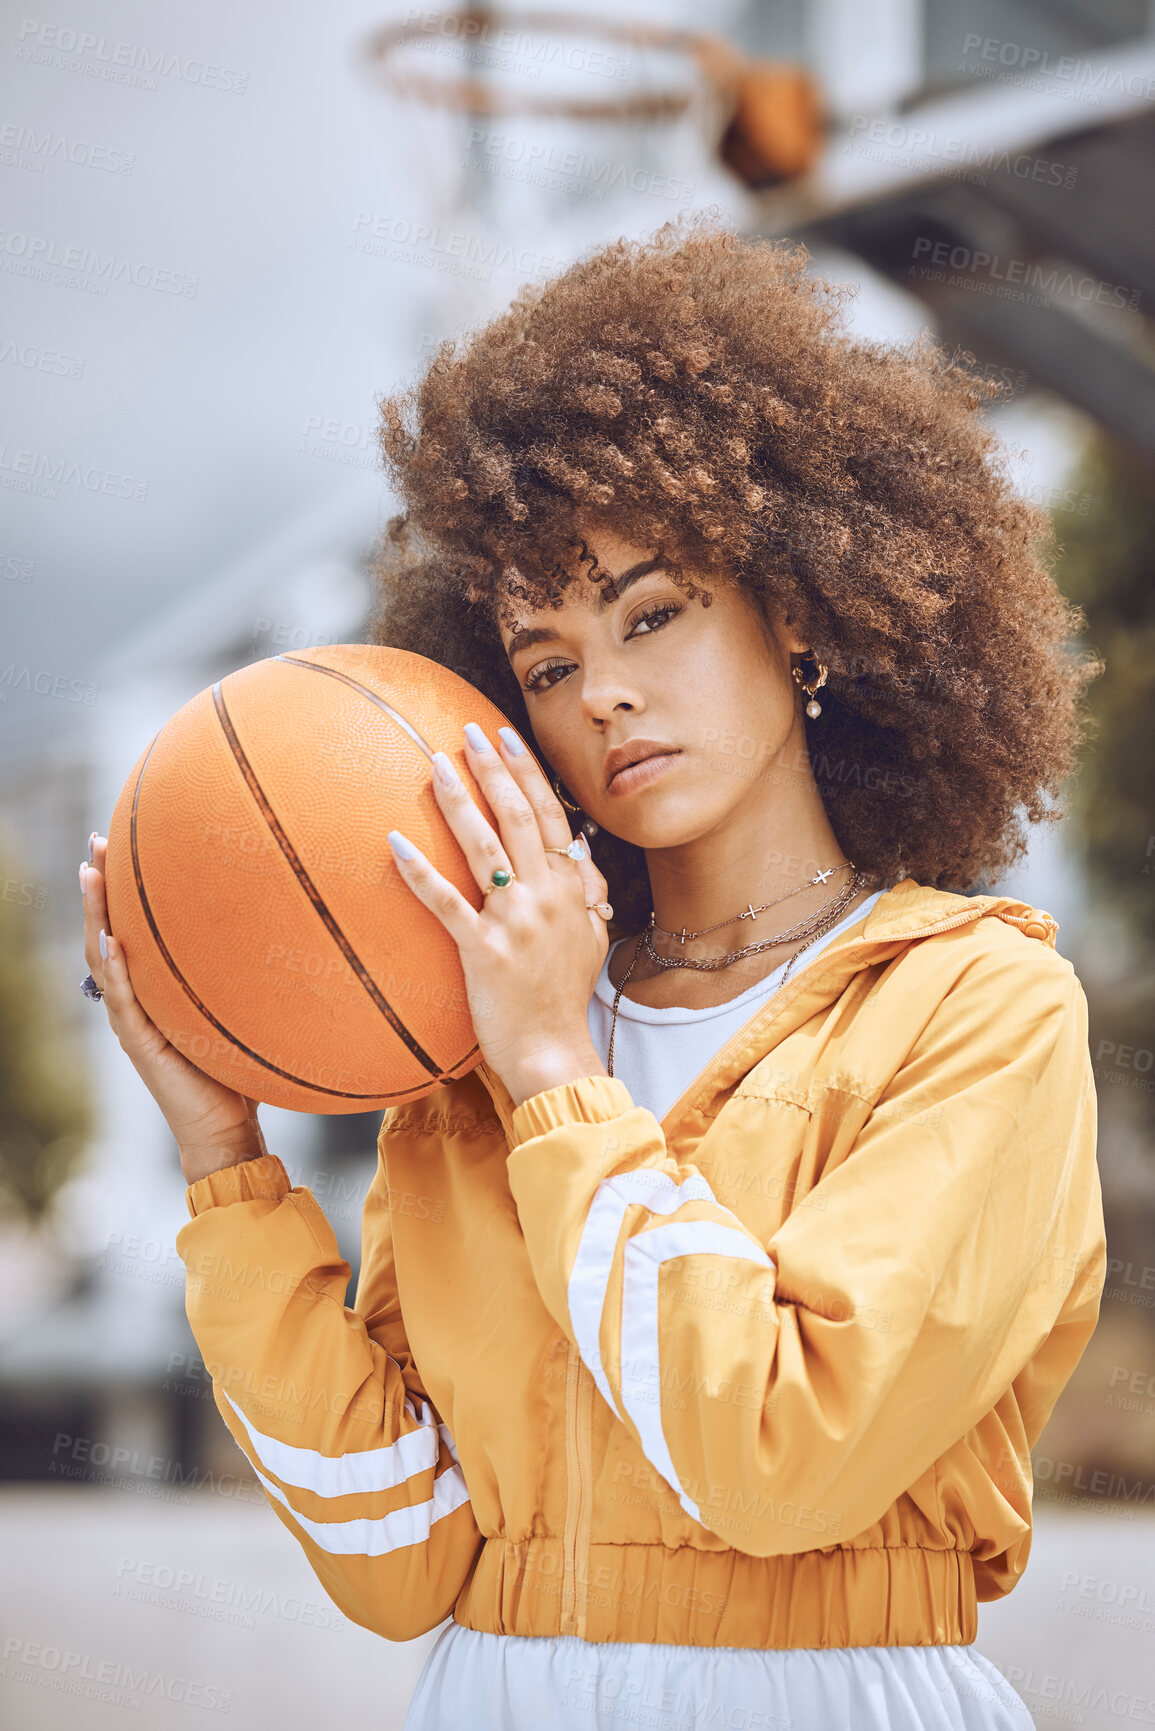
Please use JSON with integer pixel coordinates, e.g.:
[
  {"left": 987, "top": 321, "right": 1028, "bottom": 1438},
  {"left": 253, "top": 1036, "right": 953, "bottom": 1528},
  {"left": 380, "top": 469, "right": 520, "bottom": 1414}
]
[{"left": 367, "top": 211, "right": 1103, "bottom": 930}]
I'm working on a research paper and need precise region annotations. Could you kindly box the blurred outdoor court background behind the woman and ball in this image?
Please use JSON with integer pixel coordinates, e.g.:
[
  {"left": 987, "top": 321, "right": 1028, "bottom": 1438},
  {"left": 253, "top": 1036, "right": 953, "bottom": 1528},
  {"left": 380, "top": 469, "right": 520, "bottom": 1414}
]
[{"left": 0, "top": 0, "right": 1155, "bottom": 1731}]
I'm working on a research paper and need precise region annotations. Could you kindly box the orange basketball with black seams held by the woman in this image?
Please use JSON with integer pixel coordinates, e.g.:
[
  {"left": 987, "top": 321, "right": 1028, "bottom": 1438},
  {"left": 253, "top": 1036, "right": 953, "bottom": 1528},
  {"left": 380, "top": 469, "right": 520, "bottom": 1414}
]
[{"left": 106, "top": 644, "right": 506, "bottom": 1113}]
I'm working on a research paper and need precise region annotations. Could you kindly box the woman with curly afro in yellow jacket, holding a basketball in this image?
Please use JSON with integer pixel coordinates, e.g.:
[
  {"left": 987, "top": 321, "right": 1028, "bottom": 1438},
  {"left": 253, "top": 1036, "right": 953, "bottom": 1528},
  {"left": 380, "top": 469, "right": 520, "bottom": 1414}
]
[{"left": 81, "top": 218, "right": 1105, "bottom": 1731}]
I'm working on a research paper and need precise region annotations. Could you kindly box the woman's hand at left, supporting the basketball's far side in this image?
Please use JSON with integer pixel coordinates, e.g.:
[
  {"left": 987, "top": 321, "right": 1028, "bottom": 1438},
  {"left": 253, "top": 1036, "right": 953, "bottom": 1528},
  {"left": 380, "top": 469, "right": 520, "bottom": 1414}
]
[{"left": 80, "top": 836, "right": 268, "bottom": 1184}]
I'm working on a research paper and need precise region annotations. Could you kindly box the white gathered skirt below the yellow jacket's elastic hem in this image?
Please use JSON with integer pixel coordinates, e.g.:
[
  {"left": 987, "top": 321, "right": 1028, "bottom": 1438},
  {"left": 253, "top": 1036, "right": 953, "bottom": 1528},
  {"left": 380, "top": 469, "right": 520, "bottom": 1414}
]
[{"left": 403, "top": 1622, "right": 1034, "bottom": 1731}]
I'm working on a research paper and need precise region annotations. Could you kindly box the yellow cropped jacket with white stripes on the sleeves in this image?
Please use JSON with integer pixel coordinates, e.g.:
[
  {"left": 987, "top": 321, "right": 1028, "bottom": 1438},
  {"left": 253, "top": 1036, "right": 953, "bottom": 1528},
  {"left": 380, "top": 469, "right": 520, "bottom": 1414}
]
[{"left": 177, "top": 878, "right": 1107, "bottom": 1648}]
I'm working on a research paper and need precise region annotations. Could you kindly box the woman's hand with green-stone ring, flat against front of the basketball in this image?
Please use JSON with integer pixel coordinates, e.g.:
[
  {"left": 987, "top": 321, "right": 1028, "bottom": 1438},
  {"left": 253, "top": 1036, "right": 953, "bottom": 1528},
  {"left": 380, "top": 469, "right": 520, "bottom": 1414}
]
[{"left": 390, "top": 722, "right": 610, "bottom": 1106}]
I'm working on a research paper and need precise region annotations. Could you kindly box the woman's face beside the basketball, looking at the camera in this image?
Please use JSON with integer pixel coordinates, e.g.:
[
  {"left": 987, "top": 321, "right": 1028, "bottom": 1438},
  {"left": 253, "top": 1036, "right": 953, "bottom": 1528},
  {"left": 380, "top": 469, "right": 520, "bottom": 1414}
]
[{"left": 502, "top": 533, "right": 809, "bottom": 848}]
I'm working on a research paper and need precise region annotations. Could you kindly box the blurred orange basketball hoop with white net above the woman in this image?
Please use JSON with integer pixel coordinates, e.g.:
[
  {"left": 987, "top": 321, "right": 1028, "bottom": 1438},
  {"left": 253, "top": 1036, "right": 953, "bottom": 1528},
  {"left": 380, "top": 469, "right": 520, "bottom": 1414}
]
[{"left": 350, "top": 7, "right": 821, "bottom": 350}]
